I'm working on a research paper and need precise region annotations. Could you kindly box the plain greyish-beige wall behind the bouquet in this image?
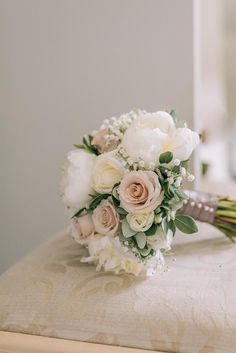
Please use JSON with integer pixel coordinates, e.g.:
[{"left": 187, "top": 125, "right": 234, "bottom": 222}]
[{"left": 0, "top": 0, "right": 194, "bottom": 271}]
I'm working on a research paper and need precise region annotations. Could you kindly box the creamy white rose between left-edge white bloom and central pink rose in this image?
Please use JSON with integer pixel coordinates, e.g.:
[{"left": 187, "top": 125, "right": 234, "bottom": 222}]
[{"left": 93, "top": 151, "right": 124, "bottom": 193}]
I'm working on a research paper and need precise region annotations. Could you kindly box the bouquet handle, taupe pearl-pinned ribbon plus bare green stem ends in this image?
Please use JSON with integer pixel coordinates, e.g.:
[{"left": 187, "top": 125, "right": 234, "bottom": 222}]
[{"left": 179, "top": 190, "right": 236, "bottom": 242}]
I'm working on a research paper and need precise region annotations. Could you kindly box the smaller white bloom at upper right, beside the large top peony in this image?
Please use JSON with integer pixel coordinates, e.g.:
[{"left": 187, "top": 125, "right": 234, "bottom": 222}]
[{"left": 164, "top": 128, "right": 200, "bottom": 161}]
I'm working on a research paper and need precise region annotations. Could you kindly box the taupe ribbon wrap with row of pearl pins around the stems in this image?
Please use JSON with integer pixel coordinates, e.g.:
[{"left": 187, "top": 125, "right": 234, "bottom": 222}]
[{"left": 179, "top": 190, "right": 219, "bottom": 223}]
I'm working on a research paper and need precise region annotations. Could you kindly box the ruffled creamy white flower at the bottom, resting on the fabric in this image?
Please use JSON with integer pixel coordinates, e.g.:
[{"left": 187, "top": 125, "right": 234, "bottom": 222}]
[{"left": 81, "top": 235, "right": 144, "bottom": 276}]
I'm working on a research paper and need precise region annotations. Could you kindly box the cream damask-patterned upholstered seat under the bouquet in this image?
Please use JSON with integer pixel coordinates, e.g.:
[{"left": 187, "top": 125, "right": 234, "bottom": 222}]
[{"left": 0, "top": 224, "right": 236, "bottom": 353}]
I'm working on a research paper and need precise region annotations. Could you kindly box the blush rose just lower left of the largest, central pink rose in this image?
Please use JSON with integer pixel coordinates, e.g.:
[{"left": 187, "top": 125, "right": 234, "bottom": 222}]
[{"left": 92, "top": 200, "right": 120, "bottom": 235}]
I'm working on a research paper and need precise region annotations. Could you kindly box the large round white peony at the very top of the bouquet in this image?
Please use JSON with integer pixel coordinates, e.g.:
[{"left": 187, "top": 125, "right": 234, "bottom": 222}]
[{"left": 122, "top": 112, "right": 175, "bottom": 167}]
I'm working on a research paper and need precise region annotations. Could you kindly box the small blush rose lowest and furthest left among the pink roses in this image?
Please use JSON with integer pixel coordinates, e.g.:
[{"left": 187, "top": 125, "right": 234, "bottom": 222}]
[{"left": 72, "top": 214, "right": 95, "bottom": 244}]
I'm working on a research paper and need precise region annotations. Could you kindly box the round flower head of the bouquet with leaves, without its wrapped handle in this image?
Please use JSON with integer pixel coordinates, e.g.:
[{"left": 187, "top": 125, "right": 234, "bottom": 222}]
[{"left": 62, "top": 110, "right": 204, "bottom": 275}]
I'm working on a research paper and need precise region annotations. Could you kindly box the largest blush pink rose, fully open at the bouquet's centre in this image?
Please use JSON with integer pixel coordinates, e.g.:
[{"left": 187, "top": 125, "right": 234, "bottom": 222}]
[{"left": 118, "top": 171, "right": 164, "bottom": 214}]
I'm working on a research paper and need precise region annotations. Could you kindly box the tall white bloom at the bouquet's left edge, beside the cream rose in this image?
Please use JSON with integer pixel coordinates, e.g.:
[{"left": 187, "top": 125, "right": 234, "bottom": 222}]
[{"left": 61, "top": 149, "right": 96, "bottom": 209}]
